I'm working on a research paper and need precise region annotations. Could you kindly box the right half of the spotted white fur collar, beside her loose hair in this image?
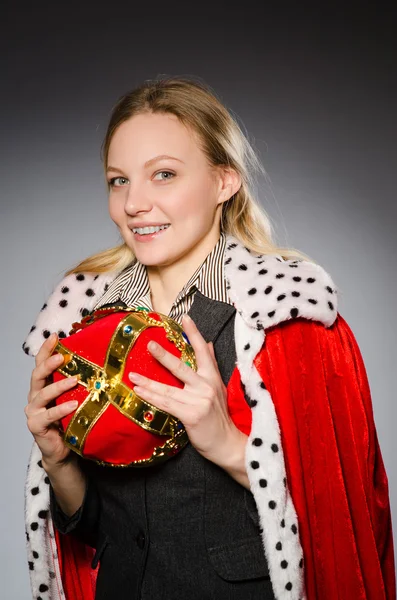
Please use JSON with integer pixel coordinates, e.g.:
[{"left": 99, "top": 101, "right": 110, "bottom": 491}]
[{"left": 225, "top": 239, "right": 338, "bottom": 330}]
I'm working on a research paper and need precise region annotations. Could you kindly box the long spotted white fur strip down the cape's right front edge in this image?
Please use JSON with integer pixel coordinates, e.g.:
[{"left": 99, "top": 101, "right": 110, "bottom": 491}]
[{"left": 235, "top": 313, "right": 305, "bottom": 600}]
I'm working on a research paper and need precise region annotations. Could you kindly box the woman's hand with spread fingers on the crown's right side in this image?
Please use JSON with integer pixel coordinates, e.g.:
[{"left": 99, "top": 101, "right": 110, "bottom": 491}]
[{"left": 129, "top": 315, "right": 247, "bottom": 473}]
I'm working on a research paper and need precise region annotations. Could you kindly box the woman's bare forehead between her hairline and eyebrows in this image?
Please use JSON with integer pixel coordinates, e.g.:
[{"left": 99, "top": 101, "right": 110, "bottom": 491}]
[{"left": 109, "top": 113, "right": 204, "bottom": 166}]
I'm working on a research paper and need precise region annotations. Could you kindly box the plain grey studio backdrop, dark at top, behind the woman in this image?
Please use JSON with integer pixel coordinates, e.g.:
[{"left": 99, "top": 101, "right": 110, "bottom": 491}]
[{"left": 0, "top": 3, "right": 397, "bottom": 600}]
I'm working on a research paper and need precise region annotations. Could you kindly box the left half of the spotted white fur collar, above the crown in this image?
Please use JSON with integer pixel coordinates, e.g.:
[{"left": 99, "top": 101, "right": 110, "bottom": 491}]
[{"left": 22, "top": 272, "right": 118, "bottom": 356}]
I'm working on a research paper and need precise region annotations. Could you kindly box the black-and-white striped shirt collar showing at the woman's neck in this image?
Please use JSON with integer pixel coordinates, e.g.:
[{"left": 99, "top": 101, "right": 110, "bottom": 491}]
[{"left": 94, "top": 233, "right": 233, "bottom": 324}]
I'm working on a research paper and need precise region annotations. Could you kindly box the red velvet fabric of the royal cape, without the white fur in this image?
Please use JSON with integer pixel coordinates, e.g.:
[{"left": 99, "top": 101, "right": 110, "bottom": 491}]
[{"left": 56, "top": 314, "right": 396, "bottom": 600}]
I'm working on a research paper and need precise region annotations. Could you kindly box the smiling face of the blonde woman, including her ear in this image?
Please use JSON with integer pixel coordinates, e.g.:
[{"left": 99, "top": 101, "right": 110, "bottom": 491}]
[{"left": 107, "top": 113, "right": 239, "bottom": 266}]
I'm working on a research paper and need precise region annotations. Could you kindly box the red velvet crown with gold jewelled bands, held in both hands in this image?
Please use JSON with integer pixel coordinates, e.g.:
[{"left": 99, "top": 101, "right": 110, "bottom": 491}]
[{"left": 54, "top": 310, "right": 194, "bottom": 466}]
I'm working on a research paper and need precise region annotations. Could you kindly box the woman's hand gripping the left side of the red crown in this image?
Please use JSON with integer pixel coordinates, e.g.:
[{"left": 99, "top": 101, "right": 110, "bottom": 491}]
[{"left": 25, "top": 333, "right": 78, "bottom": 468}]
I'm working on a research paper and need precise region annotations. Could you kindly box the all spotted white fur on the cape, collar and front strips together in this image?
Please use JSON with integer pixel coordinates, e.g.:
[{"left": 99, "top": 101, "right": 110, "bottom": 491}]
[{"left": 23, "top": 236, "right": 337, "bottom": 600}]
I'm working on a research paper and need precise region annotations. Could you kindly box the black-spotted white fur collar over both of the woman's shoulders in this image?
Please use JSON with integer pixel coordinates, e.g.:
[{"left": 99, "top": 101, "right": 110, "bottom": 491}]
[{"left": 23, "top": 235, "right": 337, "bottom": 356}]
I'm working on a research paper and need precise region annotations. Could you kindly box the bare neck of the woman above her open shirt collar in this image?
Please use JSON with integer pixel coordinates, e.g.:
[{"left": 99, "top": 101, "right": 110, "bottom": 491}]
[{"left": 146, "top": 230, "right": 220, "bottom": 315}]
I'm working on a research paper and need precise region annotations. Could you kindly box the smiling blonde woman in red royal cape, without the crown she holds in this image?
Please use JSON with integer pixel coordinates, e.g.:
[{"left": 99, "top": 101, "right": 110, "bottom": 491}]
[{"left": 24, "top": 78, "right": 395, "bottom": 600}]
